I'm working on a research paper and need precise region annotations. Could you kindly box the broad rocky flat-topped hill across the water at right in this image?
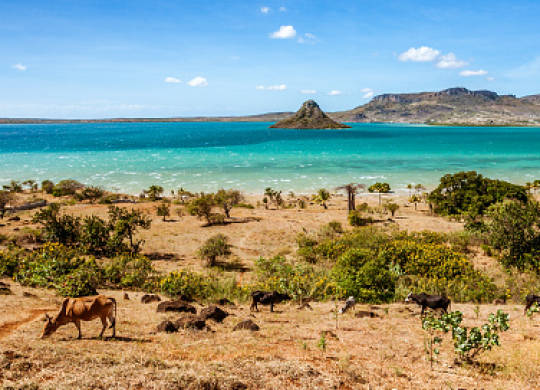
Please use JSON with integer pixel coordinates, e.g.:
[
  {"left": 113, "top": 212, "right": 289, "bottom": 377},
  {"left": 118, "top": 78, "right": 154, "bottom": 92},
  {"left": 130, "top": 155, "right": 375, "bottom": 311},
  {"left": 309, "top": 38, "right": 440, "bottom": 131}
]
[{"left": 329, "top": 87, "right": 540, "bottom": 126}]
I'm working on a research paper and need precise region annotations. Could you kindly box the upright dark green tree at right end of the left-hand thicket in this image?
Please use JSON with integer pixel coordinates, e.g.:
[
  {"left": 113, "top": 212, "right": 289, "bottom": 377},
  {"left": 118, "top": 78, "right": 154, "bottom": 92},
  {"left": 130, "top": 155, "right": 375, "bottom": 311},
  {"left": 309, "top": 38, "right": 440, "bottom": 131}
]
[{"left": 109, "top": 206, "right": 152, "bottom": 253}]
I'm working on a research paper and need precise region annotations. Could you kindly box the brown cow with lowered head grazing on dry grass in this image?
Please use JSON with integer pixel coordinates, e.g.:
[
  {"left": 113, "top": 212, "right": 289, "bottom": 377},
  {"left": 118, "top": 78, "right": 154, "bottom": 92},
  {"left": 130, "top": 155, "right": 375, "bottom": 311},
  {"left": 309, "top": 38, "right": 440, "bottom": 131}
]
[{"left": 41, "top": 295, "right": 116, "bottom": 339}]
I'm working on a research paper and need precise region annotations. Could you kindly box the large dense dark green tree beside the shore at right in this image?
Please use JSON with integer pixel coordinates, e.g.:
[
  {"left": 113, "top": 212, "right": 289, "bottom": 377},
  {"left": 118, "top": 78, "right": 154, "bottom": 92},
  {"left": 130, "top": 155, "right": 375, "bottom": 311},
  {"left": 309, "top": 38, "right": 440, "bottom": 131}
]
[{"left": 428, "top": 171, "right": 528, "bottom": 215}]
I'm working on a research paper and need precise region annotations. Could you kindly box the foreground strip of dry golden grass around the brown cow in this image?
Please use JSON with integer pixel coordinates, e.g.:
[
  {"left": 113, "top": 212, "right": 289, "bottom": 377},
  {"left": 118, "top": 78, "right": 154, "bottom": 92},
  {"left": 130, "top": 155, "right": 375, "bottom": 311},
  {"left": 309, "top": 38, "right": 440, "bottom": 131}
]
[{"left": 0, "top": 284, "right": 540, "bottom": 389}]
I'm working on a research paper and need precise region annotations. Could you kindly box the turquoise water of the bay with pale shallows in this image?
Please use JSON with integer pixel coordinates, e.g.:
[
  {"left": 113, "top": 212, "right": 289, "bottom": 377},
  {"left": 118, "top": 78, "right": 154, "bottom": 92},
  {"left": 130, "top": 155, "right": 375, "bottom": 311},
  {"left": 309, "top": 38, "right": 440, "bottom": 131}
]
[{"left": 0, "top": 123, "right": 540, "bottom": 194}]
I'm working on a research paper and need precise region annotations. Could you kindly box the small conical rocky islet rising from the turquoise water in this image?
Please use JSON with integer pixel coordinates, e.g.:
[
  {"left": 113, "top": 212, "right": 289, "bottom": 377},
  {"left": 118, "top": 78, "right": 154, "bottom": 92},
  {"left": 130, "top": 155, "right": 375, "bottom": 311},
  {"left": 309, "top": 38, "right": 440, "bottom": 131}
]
[{"left": 270, "top": 100, "right": 350, "bottom": 129}]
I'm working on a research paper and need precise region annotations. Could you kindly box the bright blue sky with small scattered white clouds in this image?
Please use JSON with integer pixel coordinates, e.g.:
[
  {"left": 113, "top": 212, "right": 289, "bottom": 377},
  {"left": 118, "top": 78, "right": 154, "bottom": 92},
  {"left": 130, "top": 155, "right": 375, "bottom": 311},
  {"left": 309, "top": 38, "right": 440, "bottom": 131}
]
[{"left": 0, "top": 0, "right": 540, "bottom": 119}]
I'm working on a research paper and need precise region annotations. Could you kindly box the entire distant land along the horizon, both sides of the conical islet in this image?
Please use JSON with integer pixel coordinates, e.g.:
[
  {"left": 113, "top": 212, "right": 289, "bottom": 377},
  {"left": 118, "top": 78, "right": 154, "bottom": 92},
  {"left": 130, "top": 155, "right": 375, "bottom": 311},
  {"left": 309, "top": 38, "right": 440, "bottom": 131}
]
[{"left": 0, "top": 87, "right": 540, "bottom": 126}]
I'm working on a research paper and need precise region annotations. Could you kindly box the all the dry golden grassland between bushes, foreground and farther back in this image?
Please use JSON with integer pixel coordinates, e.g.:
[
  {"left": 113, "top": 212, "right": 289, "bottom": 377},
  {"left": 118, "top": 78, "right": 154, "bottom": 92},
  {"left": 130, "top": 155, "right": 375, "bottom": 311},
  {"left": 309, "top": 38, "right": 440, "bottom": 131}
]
[{"left": 0, "top": 192, "right": 540, "bottom": 389}]
